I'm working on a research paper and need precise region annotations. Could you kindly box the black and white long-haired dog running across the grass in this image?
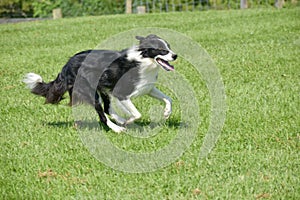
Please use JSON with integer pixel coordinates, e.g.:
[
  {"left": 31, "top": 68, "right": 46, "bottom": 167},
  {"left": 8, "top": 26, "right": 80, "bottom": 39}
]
[{"left": 24, "top": 34, "right": 177, "bottom": 133}]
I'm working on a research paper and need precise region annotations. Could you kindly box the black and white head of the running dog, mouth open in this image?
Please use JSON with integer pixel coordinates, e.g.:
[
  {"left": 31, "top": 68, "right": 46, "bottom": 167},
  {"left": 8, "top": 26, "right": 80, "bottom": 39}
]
[{"left": 136, "top": 34, "right": 177, "bottom": 71}]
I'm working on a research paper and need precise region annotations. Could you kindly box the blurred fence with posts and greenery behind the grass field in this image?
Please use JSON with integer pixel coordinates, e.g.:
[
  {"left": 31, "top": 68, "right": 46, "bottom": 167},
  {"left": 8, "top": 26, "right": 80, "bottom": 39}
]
[{"left": 0, "top": 0, "right": 299, "bottom": 18}]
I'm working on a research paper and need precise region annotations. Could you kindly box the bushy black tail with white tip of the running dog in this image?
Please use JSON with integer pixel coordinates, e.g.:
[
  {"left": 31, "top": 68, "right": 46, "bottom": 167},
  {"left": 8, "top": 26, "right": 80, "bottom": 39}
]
[{"left": 23, "top": 73, "right": 67, "bottom": 104}]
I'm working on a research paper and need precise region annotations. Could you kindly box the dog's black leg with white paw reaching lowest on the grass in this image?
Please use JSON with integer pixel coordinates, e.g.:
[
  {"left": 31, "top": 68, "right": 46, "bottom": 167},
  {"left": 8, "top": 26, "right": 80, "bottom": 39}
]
[{"left": 95, "top": 93, "right": 125, "bottom": 133}]
